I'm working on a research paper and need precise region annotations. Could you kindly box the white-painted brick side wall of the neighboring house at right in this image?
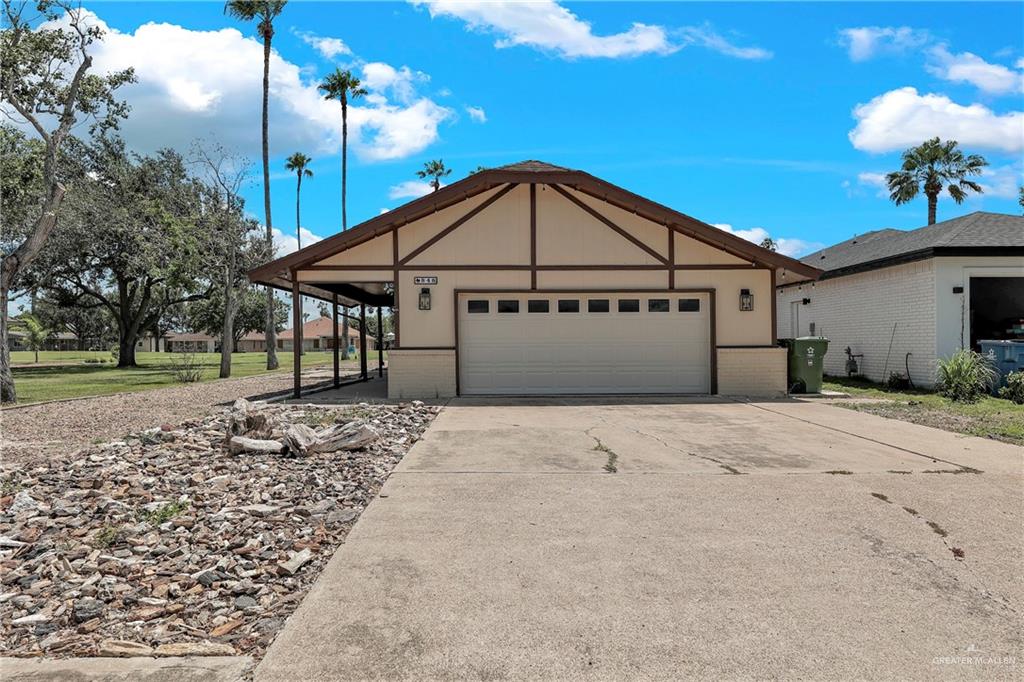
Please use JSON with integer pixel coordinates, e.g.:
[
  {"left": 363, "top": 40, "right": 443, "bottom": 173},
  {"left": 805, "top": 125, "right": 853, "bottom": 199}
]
[{"left": 776, "top": 260, "right": 936, "bottom": 386}]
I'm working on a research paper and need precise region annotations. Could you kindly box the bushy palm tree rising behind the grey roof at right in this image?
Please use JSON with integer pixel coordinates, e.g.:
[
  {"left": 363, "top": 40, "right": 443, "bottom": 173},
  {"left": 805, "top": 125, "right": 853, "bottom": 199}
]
[{"left": 886, "top": 137, "right": 988, "bottom": 225}]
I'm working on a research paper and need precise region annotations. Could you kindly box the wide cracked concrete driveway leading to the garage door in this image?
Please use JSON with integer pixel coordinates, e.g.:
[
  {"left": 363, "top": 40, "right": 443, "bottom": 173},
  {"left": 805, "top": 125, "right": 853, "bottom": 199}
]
[{"left": 256, "top": 398, "right": 1024, "bottom": 681}]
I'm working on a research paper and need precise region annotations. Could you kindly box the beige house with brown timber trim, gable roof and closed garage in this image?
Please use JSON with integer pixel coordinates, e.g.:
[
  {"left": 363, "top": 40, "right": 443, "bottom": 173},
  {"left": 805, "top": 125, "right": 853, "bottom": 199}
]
[{"left": 250, "top": 161, "right": 821, "bottom": 398}]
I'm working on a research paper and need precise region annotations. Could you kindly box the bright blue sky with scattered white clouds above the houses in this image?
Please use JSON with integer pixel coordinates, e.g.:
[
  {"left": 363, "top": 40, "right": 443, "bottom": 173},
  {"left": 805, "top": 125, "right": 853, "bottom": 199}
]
[{"left": 66, "top": 0, "right": 1024, "bottom": 255}]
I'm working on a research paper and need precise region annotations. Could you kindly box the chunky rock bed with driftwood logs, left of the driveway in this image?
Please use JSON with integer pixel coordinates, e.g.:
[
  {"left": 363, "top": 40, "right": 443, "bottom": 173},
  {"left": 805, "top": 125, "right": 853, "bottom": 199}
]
[{"left": 0, "top": 399, "right": 439, "bottom": 657}]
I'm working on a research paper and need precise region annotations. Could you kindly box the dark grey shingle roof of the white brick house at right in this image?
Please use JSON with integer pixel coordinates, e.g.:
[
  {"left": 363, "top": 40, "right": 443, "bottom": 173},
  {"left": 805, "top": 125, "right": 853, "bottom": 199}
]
[{"left": 801, "top": 211, "right": 1024, "bottom": 276}]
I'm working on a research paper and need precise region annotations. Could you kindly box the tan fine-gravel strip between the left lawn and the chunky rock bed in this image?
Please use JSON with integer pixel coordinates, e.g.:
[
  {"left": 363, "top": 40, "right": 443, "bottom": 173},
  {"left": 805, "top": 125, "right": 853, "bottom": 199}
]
[{"left": 0, "top": 370, "right": 348, "bottom": 463}]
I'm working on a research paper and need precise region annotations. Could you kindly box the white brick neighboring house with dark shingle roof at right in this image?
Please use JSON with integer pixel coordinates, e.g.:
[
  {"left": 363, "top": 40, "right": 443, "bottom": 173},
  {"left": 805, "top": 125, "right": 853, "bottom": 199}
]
[{"left": 777, "top": 211, "right": 1024, "bottom": 387}]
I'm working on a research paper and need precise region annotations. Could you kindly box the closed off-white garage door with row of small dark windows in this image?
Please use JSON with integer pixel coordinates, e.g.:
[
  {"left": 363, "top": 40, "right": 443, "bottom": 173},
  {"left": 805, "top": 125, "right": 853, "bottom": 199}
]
[{"left": 459, "top": 292, "right": 711, "bottom": 395}]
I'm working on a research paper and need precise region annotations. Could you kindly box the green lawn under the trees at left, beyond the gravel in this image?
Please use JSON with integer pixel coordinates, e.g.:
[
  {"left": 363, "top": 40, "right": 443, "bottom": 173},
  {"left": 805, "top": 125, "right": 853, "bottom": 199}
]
[{"left": 11, "top": 351, "right": 387, "bottom": 404}]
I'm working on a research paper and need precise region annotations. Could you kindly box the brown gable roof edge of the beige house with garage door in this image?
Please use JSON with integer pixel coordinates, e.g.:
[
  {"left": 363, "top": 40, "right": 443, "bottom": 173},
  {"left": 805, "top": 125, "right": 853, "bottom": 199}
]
[{"left": 249, "top": 160, "right": 821, "bottom": 286}]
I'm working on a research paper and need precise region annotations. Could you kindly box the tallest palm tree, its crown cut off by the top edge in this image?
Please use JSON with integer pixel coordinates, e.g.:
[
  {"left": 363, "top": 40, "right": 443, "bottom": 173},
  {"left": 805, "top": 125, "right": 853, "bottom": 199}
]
[{"left": 224, "top": 0, "right": 288, "bottom": 370}]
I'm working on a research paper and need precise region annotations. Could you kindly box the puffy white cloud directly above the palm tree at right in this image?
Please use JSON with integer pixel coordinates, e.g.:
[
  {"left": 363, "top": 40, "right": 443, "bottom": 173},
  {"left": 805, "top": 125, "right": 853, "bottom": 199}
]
[{"left": 849, "top": 87, "right": 1024, "bottom": 153}]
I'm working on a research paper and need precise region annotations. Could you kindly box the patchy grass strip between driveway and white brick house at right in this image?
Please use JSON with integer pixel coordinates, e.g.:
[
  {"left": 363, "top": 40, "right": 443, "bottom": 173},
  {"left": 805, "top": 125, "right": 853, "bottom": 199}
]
[{"left": 823, "top": 377, "right": 1024, "bottom": 445}]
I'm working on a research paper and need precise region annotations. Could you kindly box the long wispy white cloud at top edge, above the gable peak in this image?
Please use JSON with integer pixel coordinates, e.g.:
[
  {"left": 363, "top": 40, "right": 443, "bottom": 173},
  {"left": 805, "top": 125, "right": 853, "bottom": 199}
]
[{"left": 411, "top": 0, "right": 771, "bottom": 59}]
